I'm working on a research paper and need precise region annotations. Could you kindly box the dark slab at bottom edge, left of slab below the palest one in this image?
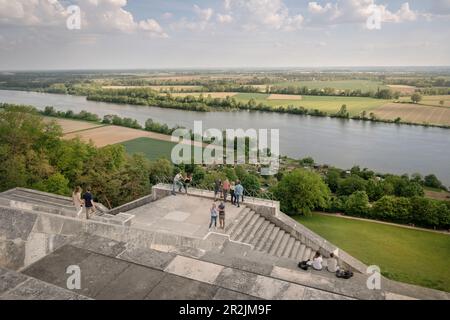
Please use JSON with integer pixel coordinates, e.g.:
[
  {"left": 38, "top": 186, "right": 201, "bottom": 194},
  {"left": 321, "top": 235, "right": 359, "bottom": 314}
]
[{"left": 95, "top": 264, "right": 165, "bottom": 300}]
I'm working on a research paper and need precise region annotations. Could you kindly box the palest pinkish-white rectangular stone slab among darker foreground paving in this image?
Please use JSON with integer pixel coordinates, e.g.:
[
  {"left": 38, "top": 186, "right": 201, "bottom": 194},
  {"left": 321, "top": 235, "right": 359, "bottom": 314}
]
[{"left": 164, "top": 256, "right": 223, "bottom": 283}]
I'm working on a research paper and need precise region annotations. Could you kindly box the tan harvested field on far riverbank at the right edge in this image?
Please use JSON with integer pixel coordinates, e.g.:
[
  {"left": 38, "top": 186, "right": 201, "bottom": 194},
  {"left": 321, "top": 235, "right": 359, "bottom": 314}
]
[{"left": 373, "top": 103, "right": 450, "bottom": 125}]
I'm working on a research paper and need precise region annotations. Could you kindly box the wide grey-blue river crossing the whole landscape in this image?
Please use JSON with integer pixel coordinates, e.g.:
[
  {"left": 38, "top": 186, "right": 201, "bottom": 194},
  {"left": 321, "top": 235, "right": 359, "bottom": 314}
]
[{"left": 0, "top": 90, "right": 450, "bottom": 186}]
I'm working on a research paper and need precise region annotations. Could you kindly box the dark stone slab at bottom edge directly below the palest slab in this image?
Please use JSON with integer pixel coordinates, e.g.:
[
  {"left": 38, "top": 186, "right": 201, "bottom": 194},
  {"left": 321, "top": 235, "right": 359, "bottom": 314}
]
[{"left": 145, "top": 274, "right": 218, "bottom": 300}]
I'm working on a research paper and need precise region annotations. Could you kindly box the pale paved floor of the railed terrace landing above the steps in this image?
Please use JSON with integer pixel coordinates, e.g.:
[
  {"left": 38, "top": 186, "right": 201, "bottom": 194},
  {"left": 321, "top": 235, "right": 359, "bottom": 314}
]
[{"left": 127, "top": 194, "right": 244, "bottom": 238}]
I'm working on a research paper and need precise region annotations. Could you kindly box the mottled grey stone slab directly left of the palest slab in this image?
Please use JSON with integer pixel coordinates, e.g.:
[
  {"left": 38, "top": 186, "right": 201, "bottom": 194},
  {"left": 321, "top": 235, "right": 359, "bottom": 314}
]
[{"left": 118, "top": 247, "right": 176, "bottom": 270}]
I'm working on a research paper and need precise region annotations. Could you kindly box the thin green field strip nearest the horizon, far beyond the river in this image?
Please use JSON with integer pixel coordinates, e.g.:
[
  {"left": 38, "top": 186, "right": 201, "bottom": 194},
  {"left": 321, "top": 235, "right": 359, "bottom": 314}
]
[{"left": 273, "top": 80, "right": 387, "bottom": 92}]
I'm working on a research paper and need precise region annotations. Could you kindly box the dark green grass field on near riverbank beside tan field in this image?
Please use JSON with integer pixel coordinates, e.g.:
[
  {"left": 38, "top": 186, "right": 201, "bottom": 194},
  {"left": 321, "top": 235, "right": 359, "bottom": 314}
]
[{"left": 121, "top": 138, "right": 203, "bottom": 161}]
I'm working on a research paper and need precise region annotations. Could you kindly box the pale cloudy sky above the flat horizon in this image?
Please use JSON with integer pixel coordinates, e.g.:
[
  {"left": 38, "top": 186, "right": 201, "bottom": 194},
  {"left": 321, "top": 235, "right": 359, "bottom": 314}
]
[{"left": 0, "top": 0, "right": 450, "bottom": 70}]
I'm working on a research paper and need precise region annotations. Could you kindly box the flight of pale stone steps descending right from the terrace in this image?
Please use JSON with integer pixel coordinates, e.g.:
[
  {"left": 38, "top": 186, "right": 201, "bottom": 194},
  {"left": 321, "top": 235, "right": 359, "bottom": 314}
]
[{"left": 225, "top": 205, "right": 316, "bottom": 261}]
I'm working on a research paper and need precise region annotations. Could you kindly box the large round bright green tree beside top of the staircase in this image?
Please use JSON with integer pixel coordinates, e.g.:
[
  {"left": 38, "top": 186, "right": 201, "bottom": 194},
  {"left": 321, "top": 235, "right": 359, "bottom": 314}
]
[{"left": 273, "top": 169, "right": 330, "bottom": 215}]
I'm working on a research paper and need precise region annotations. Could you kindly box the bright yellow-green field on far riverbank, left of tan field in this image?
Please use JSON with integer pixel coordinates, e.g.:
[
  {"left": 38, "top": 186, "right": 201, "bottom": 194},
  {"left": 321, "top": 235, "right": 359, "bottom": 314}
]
[{"left": 233, "top": 93, "right": 389, "bottom": 116}]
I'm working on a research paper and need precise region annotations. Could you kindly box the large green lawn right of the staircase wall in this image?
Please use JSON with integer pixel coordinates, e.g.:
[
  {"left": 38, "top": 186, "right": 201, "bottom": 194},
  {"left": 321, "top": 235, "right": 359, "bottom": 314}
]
[{"left": 295, "top": 214, "right": 450, "bottom": 292}]
